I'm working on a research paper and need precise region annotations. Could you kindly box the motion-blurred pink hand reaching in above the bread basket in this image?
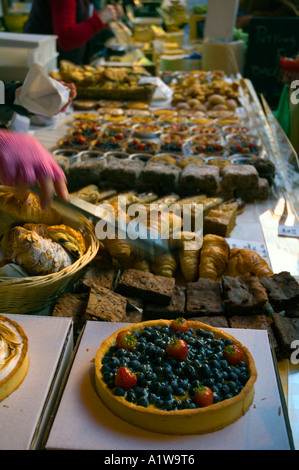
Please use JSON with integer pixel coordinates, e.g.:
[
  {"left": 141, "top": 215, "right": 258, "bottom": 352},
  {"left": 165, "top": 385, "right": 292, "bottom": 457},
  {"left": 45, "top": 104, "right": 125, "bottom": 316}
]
[{"left": 0, "top": 129, "right": 69, "bottom": 209}]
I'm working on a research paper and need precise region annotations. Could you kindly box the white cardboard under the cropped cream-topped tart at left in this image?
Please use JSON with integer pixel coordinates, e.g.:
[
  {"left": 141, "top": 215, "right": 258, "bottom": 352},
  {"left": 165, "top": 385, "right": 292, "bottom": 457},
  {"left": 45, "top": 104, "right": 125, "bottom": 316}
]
[{"left": 0, "top": 313, "right": 73, "bottom": 450}]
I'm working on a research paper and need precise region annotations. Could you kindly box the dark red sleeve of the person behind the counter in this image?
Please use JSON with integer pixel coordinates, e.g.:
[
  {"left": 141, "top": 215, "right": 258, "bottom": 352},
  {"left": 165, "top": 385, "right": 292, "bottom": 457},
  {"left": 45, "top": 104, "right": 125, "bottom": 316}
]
[{"left": 47, "top": 0, "right": 106, "bottom": 51}]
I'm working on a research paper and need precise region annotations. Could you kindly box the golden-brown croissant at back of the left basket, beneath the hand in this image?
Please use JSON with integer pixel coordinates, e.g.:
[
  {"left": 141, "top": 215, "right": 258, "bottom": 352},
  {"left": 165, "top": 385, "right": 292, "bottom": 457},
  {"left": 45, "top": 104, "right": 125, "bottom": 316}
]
[{"left": 0, "top": 191, "right": 62, "bottom": 225}]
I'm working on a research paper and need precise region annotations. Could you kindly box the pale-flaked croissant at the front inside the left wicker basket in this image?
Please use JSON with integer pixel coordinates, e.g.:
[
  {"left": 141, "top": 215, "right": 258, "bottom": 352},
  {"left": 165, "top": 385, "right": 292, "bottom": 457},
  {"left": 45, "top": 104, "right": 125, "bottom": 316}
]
[{"left": 12, "top": 227, "right": 72, "bottom": 276}]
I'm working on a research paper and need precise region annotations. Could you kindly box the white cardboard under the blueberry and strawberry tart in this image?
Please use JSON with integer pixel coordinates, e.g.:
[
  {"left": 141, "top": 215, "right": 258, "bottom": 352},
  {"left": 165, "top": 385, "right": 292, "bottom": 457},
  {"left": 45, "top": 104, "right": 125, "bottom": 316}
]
[{"left": 45, "top": 322, "right": 293, "bottom": 452}]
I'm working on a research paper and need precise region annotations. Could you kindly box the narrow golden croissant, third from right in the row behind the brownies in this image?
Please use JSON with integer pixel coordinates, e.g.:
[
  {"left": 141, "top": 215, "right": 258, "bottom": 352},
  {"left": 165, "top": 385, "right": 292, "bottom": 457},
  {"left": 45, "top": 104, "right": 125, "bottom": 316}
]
[{"left": 178, "top": 232, "right": 203, "bottom": 282}]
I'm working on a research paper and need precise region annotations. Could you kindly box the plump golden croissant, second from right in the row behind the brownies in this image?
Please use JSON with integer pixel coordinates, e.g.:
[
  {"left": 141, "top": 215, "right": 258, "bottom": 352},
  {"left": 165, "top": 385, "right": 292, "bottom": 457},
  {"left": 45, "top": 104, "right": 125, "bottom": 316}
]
[{"left": 199, "top": 234, "right": 230, "bottom": 281}]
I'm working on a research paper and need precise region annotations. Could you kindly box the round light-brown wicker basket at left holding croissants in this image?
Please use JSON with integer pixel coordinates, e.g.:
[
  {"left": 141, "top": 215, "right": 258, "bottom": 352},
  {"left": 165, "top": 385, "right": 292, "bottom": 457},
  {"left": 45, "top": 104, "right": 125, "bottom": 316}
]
[{"left": 0, "top": 192, "right": 100, "bottom": 314}]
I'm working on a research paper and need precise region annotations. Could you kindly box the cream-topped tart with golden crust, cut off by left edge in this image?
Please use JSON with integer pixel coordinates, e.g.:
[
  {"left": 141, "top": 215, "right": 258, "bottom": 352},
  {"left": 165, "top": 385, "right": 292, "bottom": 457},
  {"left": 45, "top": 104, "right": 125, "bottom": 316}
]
[{"left": 0, "top": 315, "right": 29, "bottom": 401}]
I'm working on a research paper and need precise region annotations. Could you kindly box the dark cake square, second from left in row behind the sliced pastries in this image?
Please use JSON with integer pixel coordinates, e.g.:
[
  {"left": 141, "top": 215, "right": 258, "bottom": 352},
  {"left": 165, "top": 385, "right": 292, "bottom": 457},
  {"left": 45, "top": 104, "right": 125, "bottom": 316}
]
[{"left": 102, "top": 157, "right": 144, "bottom": 189}]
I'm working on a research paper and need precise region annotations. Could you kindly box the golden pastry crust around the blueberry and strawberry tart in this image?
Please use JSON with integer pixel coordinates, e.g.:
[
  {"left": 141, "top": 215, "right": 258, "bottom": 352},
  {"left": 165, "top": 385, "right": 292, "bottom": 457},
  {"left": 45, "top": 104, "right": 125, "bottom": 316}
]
[{"left": 95, "top": 320, "right": 257, "bottom": 435}]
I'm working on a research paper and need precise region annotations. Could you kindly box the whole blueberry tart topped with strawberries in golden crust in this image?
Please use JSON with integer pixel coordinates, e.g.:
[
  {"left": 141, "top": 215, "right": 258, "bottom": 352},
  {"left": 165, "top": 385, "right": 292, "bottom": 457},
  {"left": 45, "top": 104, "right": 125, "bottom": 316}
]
[{"left": 95, "top": 319, "right": 257, "bottom": 435}]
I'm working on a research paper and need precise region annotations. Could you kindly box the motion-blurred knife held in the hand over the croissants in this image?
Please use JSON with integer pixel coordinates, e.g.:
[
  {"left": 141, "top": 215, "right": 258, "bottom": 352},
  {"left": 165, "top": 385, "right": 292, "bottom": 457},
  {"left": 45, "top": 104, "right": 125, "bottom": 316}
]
[{"left": 51, "top": 194, "right": 175, "bottom": 261}]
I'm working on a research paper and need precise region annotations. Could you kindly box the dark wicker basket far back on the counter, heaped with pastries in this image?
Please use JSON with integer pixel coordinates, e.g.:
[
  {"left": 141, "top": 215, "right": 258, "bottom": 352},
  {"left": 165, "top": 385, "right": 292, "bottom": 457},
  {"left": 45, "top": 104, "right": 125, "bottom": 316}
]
[{"left": 76, "top": 84, "right": 156, "bottom": 102}]
